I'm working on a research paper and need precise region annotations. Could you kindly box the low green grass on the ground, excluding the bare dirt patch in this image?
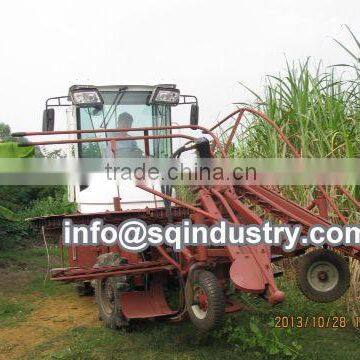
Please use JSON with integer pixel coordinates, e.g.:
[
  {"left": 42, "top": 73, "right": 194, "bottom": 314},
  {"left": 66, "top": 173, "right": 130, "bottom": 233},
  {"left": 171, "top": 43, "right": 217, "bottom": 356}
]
[{"left": 0, "top": 248, "right": 360, "bottom": 360}]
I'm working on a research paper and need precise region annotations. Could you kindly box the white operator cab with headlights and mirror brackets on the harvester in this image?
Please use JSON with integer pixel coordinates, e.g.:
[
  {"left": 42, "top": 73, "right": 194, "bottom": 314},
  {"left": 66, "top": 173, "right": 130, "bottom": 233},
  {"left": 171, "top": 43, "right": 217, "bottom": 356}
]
[{"left": 43, "top": 85, "right": 198, "bottom": 213}]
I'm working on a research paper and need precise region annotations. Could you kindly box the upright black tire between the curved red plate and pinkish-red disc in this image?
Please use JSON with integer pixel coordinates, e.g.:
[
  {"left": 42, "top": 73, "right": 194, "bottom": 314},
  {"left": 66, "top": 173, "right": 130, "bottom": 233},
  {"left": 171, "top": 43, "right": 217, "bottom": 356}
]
[{"left": 185, "top": 270, "right": 225, "bottom": 332}]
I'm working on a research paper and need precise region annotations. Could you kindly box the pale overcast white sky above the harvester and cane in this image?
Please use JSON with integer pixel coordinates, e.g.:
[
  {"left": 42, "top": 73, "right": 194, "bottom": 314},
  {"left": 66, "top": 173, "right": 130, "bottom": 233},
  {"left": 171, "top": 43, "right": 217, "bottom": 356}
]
[{"left": 0, "top": 0, "right": 360, "bottom": 131}]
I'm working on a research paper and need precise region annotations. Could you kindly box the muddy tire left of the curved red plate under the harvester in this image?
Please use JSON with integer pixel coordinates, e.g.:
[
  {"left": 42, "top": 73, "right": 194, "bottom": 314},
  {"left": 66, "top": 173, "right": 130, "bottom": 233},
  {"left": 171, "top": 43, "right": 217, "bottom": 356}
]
[{"left": 95, "top": 277, "right": 128, "bottom": 330}]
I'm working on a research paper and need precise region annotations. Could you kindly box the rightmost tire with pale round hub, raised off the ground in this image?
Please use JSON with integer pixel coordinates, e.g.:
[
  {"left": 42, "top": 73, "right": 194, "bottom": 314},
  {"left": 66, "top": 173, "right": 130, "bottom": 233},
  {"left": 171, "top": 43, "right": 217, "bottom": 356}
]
[{"left": 296, "top": 249, "right": 350, "bottom": 303}]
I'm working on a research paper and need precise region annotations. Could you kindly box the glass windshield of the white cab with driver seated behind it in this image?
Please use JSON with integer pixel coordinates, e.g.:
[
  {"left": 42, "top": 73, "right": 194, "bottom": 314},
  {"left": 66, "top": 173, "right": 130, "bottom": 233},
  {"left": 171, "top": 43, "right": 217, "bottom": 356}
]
[{"left": 77, "top": 90, "right": 171, "bottom": 158}]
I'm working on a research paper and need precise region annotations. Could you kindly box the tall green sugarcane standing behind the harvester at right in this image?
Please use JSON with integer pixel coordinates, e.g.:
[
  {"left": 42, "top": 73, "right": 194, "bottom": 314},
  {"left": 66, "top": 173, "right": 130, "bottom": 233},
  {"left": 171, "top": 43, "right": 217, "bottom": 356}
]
[{"left": 230, "top": 60, "right": 360, "bottom": 222}]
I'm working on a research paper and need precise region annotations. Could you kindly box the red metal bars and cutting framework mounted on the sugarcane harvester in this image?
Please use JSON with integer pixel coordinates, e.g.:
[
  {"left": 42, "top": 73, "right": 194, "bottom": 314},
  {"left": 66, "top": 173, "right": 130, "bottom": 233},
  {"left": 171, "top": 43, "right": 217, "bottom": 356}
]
[{"left": 14, "top": 108, "right": 360, "bottom": 319}]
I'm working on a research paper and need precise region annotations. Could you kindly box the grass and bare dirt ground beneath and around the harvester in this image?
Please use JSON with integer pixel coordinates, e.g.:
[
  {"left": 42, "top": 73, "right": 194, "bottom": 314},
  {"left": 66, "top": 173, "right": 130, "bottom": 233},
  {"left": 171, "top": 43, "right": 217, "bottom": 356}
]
[{"left": 0, "top": 248, "right": 359, "bottom": 360}]
